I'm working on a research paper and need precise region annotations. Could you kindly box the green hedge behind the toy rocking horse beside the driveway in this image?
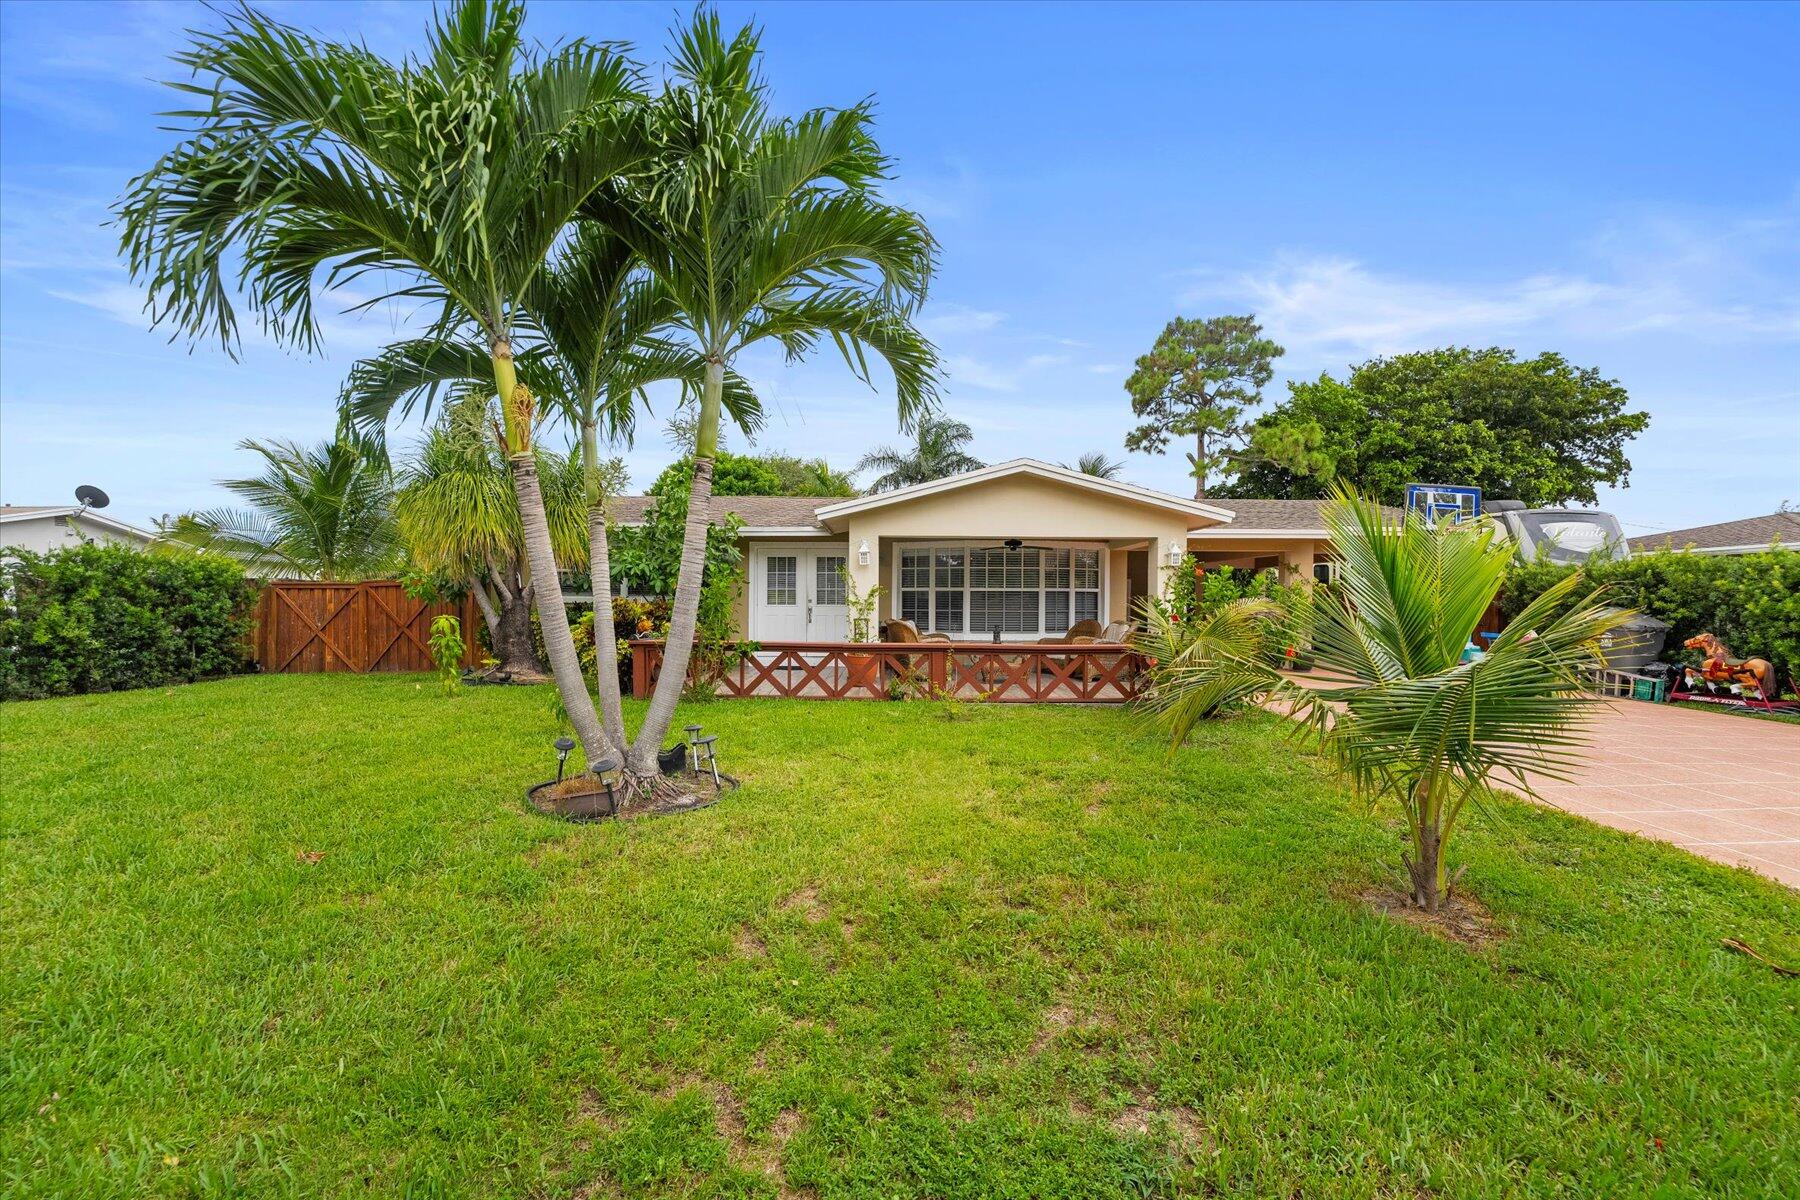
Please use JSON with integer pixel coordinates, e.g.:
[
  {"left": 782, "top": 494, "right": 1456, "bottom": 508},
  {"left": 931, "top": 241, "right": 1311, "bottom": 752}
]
[{"left": 1499, "top": 549, "right": 1800, "bottom": 691}]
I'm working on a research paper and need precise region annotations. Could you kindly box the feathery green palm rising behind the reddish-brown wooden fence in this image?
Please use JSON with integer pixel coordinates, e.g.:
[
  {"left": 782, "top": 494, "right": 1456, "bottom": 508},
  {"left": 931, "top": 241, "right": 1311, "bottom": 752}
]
[{"left": 160, "top": 435, "right": 400, "bottom": 579}]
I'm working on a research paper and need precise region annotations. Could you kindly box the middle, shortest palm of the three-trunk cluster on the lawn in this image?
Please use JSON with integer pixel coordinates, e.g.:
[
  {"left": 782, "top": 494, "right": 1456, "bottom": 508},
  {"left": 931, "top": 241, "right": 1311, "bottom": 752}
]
[{"left": 344, "top": 221, "right": 763, "bottom": 761}]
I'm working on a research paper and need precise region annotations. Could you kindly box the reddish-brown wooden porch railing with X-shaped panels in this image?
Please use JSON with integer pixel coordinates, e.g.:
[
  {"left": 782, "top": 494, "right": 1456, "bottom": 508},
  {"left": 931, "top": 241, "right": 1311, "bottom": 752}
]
[{"left": 632, "top": 640, "right": 1143, "bottom": 703}]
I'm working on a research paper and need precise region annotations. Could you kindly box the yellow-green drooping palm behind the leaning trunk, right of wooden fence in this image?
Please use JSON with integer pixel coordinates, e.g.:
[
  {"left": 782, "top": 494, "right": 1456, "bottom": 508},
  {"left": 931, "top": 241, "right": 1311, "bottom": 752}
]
[{"left": 394, "top": 399, "right": 587, "bottom": 682}]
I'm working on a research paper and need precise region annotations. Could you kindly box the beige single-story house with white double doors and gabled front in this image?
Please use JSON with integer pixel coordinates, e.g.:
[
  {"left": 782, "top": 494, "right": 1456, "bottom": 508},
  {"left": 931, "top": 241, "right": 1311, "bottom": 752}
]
[{"left": 612, "top": 459, "right": 1375, "bottom": 642}]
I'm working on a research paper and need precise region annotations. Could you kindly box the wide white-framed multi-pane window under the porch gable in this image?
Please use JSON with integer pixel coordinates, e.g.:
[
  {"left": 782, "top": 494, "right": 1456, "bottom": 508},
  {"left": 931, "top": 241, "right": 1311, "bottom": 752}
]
[{"left": 895, "top": 545, "right": 1102, "bottom": 637}]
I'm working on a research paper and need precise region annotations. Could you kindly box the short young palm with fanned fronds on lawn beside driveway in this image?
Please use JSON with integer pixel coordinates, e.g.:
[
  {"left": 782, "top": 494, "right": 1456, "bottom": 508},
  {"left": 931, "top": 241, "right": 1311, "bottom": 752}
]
[{"left": 1152, "top": 489, "right": 1633, "bottom": 912}]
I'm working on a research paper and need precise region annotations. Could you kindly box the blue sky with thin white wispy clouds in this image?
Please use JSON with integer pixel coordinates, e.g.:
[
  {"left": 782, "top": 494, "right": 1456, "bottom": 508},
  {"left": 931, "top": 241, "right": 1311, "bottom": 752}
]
[{"left": 0, "top": 0, "right": 1800, "bottom": 533}]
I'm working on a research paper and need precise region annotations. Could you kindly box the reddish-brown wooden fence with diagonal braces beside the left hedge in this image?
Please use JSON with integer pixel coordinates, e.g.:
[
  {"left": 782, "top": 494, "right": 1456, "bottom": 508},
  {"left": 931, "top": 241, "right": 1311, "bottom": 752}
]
[{"left": 256, "top": 579, "right": 482, "bottom": 675}]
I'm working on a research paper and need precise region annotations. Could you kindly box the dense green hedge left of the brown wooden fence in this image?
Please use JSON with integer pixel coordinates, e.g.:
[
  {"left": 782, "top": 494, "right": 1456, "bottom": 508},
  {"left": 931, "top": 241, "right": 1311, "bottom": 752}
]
[{"left": 0, "top": 543, "right": 257, "bottom": 700}]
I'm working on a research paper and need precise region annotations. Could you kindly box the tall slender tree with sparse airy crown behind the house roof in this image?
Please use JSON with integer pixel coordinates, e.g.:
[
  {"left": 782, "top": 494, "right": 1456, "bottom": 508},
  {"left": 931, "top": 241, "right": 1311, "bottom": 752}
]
[{"left": 1125, "top": 317, "right": 1283, "bottom": 497}]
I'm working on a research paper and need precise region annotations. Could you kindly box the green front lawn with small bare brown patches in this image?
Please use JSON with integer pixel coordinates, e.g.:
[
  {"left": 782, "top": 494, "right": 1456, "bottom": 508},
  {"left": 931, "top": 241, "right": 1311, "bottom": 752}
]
[{"left": 0, "top": 676, "right": 1800, "bottom": 1196}]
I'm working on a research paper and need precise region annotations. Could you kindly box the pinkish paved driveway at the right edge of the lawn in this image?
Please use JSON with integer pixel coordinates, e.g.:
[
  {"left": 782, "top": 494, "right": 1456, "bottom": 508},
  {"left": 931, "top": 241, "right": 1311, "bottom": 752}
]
[{"left": 1532, "top": 700, "right": 1800, "bottom": 887}]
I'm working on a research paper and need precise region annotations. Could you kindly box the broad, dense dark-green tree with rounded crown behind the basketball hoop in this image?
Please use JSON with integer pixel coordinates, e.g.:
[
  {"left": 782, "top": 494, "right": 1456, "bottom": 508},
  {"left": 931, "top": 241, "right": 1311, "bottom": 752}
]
[{"left": 1231, "top": 347, "right": 1649, "bottom": 507}]
